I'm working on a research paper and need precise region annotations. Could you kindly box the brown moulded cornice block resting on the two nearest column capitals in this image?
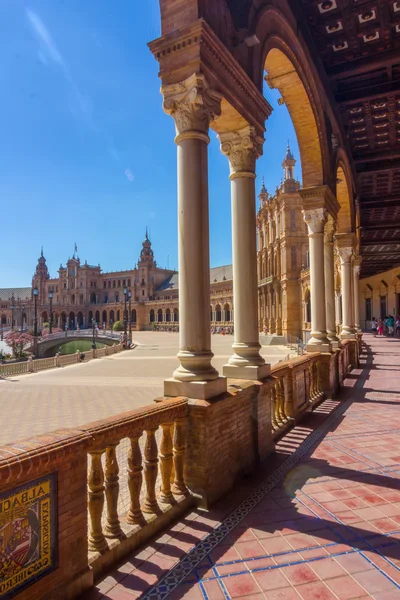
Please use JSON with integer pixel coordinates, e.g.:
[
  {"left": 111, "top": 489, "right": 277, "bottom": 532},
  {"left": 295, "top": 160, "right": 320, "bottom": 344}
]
[{"left": 149, "top": 19, "right": 272, "bottom": 132}]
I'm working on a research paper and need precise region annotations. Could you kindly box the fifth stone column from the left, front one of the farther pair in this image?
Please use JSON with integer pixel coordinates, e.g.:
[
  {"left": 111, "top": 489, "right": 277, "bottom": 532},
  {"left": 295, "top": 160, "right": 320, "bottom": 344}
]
[{"left": 336, "top": 234, "right": 355, "bottom": 339}]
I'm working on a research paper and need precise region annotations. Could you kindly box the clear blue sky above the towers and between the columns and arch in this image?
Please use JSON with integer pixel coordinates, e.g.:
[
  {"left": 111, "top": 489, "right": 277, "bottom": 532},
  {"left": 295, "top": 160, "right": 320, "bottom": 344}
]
[{"left": 0, "top": 0, "right": 300, "bottom": 287}]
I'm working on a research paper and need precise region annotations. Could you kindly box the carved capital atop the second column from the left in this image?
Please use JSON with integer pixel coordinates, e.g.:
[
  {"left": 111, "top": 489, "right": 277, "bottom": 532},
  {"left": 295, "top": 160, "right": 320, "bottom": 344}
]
[{"left": 218, "top": 126, "right": 264, "bottom": 174}]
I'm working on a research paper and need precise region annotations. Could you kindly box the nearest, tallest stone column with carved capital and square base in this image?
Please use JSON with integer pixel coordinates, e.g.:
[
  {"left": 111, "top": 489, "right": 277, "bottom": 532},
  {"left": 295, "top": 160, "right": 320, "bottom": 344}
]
[{"left": 162, "top": 74, "right": 225, "bottom": 399}]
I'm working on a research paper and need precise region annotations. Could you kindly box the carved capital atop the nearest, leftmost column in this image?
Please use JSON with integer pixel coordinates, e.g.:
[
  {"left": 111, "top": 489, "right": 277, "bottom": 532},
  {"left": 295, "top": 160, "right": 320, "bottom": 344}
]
[{"left": 161, "top": 73, "right": 222, "bottom": 134}]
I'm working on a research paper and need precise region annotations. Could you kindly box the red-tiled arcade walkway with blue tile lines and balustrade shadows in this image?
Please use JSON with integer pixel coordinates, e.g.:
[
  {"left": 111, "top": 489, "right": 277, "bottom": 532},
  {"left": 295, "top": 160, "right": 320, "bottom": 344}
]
[{"left": 85, "top": 334, "right": 400, "bottom": 600}]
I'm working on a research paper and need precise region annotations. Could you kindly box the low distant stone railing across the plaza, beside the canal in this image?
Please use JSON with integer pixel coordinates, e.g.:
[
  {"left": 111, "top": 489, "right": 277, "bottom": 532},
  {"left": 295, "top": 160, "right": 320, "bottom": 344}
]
[{"left": 0, "top": 343, "right": 124, "bottom": 377}]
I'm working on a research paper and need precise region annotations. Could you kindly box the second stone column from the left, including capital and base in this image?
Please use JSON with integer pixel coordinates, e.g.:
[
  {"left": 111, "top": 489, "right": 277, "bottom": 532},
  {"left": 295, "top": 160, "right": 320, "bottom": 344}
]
[{"left": 219, "top": 126, "right": 271, "bottom": 380}]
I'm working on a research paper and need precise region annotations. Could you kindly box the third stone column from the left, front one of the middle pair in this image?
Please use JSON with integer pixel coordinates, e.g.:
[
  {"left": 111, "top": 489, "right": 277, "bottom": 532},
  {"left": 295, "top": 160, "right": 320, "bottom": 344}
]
[{"left": 303, "top": 208, "right": 331, "bottom": 352}]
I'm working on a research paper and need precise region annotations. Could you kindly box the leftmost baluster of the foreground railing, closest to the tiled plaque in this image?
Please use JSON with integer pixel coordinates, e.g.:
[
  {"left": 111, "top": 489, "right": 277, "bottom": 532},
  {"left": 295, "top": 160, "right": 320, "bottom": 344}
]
[{"left": 88, "top": 450, "right": 108, "bottom": 552}]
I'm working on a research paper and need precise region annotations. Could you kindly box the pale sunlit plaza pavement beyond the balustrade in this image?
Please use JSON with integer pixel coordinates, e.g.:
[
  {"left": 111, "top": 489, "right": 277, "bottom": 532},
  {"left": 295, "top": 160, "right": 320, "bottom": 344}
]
[{"left": 0, "top": 331, "right": 289, "bottom": 445}]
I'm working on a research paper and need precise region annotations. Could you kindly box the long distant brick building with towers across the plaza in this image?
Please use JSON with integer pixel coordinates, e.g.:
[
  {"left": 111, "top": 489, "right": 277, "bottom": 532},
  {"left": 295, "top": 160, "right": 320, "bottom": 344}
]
[{"left": 0, "top": 231, "right": 233, "bottom": 330}]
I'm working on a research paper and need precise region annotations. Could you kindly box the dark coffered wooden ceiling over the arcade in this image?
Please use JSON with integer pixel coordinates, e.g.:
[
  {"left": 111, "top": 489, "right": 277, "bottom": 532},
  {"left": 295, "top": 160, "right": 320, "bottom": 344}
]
[{"left": 227, "top": 0, "right": 400, "bottom": 276}]
